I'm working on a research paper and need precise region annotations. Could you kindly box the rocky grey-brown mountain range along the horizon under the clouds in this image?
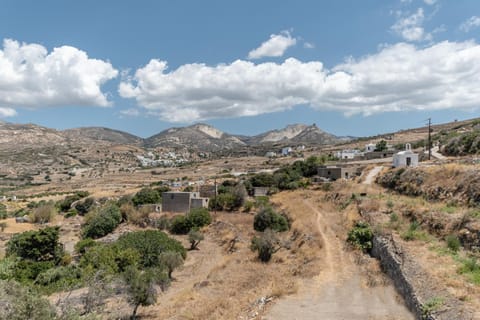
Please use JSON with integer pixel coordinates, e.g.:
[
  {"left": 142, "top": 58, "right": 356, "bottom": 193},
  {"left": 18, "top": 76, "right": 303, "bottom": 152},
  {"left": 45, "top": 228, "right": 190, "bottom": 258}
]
[{"left": 0, "top": 122, "right": 344, "bottom": 152}]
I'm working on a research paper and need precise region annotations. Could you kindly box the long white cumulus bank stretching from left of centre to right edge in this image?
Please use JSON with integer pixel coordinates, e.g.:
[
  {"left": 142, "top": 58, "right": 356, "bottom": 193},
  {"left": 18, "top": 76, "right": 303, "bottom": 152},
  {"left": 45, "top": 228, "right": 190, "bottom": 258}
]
[{"left": 119, "top": 41, "right": 480, "bottom": 122}]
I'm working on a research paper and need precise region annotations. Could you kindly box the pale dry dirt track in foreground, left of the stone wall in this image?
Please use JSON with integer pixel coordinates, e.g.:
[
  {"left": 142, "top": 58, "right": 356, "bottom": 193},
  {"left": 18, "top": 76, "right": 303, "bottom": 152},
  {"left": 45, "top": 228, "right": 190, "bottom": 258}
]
[{"left": 263, "top": 199, "right": 414, "bottom": 320}]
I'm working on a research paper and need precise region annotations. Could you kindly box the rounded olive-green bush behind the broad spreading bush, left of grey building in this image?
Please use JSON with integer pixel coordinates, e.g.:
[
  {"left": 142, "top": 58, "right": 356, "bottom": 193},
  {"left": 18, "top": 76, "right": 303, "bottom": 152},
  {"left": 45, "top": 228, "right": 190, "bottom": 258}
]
[{"left": 82, "top": 203, "right": 122, "bottom": 239}]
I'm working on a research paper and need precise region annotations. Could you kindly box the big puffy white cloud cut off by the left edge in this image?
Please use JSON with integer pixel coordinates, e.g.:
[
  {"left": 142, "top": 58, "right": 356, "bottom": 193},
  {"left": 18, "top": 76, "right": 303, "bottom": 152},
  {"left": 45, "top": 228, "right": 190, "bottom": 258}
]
[{"left": 0, "top": 39, "right": 118, "bottom": 108}]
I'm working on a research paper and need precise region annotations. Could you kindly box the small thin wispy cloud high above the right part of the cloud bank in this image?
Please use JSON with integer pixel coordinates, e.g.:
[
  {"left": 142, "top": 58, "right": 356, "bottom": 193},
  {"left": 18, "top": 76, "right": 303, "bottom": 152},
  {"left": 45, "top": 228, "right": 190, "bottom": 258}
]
[{"left": 392, "top": 8, "right": 432, "bottom": 41}]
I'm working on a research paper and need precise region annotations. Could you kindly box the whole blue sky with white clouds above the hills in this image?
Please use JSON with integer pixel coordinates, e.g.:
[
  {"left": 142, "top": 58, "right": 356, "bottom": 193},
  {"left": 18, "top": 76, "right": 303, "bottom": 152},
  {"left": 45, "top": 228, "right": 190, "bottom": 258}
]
[{"left": 0, "top": 0, "right": 480, "bottom": 137}]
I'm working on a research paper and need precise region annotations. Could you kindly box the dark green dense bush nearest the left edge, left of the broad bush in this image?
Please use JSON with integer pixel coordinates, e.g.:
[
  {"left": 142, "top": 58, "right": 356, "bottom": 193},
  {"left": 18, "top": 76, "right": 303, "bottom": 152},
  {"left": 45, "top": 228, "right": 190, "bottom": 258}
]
[{"left": 6, "top": 227, "right": 63, "bottom": 262}]
